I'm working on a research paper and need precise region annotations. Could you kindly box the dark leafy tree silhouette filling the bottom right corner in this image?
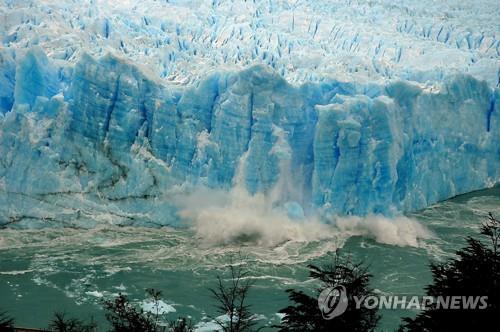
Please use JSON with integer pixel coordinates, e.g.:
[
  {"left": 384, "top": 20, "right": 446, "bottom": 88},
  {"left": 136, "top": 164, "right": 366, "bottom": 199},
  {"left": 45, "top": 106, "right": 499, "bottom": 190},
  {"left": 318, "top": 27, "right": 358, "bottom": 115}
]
[{"left": 400, "top": 213, "right": 500, "bottom": 332}]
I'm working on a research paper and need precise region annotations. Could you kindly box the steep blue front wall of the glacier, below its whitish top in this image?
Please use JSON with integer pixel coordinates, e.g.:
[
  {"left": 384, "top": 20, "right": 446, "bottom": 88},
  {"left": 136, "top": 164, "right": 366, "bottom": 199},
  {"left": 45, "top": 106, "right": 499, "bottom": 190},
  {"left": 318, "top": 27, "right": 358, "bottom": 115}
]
[{"left": 0, "top": 0, "right": 500, "bottom": 228}]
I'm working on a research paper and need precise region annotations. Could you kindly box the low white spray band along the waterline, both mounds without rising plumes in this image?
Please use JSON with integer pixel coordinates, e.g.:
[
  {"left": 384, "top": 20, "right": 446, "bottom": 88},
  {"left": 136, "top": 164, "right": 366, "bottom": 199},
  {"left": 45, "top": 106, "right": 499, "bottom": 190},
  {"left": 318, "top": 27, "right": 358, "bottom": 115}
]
[{"left": 176, "top": 187, "right": 433, "bottom": 247}]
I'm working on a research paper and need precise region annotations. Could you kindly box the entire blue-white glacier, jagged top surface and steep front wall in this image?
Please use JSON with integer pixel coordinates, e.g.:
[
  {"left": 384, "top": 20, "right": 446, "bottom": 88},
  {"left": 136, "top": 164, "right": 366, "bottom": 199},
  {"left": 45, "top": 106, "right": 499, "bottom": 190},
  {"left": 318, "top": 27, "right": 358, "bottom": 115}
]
[{"left": 0, "top": 0, "right": 500, "bottom": 228}]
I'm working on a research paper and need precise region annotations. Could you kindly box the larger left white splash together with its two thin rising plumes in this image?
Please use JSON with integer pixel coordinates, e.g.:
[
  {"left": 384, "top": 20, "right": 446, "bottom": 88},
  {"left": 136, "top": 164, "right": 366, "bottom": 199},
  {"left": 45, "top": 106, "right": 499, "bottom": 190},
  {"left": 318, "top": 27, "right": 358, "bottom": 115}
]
[{"left": 177, "top": 147, "right": 335, "bottom": 247}]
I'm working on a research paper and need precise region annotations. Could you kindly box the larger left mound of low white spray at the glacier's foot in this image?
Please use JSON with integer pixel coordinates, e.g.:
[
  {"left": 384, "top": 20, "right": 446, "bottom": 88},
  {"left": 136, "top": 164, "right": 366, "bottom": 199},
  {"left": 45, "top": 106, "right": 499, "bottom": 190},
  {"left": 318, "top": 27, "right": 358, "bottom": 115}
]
[{"left": 176, "top": 187, "right": 336, "bottom": 247}]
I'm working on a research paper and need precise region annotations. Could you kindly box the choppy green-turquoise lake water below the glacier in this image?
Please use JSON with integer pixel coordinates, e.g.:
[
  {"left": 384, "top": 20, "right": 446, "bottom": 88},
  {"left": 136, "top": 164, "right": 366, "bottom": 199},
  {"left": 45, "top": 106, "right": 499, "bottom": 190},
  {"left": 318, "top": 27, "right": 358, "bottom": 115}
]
[{"left": 0, "top": 188, "right": 500, "bottom": 331}]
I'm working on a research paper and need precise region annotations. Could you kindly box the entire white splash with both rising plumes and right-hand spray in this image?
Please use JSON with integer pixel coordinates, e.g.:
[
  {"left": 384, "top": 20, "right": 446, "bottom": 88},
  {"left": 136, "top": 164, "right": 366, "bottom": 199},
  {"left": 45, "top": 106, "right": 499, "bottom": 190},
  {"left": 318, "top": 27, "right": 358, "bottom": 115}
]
[{"left": 178, "top": 128, "right": 431, "bottom": 247}]
